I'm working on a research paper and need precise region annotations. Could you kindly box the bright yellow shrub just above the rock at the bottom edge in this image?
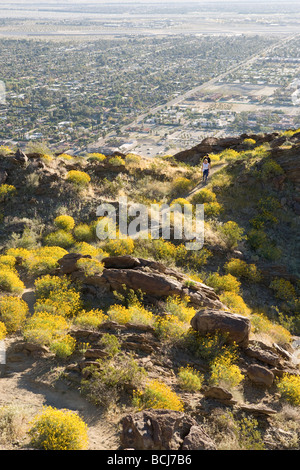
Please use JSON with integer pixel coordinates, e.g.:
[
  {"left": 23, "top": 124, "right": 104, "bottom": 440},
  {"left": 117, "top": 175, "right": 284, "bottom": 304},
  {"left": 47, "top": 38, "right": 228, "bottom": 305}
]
[{"left": 133, "top": 380, "right": 184, "bottom": 411}]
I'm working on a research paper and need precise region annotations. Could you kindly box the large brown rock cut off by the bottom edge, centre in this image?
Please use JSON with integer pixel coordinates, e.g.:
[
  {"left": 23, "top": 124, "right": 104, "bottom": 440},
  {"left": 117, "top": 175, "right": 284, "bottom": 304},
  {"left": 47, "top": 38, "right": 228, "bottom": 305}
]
[{"left": 121, "top": 409, "right": 216, "bottom": 450}]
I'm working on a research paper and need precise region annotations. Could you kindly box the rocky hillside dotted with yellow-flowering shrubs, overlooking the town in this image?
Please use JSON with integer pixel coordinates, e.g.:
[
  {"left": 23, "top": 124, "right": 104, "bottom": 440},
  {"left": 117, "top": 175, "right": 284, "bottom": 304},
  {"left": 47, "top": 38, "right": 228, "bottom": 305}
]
[{"left": 0, "top": 131, "right": 300, "bottom": 450}]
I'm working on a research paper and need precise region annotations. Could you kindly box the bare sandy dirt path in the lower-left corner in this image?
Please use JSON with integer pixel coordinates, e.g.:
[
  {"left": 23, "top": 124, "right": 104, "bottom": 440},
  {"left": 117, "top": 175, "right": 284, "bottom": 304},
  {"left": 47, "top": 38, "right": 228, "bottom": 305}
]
[{"left": 0, "top": 338, "right": 119, "bottom": 450}]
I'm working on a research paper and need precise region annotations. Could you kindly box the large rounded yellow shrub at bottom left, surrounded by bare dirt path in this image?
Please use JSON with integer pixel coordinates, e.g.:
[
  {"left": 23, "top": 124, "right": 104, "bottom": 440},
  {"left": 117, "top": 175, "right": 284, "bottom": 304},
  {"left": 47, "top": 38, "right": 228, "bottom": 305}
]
[{"left": 29, "top": 407, "right": 88, "bottom": 450}]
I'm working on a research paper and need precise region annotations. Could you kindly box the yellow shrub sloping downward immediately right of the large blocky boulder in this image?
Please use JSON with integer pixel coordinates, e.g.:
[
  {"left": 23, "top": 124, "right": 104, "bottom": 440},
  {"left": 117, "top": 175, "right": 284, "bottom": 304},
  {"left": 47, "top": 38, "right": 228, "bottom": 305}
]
[{"left": 251, "top": 313, "right": 292, "bottom": 344}]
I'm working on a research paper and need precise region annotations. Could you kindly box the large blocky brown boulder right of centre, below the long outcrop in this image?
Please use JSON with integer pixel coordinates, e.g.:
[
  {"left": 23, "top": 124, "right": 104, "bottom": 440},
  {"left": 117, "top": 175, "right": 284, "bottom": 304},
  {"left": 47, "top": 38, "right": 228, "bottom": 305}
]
[{"left": 191, "top": 308, "right": 251, "bottom": 347}]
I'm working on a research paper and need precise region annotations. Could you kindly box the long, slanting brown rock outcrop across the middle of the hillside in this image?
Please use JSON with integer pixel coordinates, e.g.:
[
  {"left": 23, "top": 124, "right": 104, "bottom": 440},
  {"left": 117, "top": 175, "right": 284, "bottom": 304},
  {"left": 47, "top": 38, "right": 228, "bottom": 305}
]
[{"left": 58, "top": 253, "right": 226, "bottom": 309}]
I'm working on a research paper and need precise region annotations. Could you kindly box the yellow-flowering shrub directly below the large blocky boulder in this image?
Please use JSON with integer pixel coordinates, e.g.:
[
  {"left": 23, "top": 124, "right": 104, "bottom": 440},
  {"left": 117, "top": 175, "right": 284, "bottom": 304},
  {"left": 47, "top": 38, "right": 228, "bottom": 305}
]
[{"left": 210, "top": 351, "right": 244, "bottom": 388}]
